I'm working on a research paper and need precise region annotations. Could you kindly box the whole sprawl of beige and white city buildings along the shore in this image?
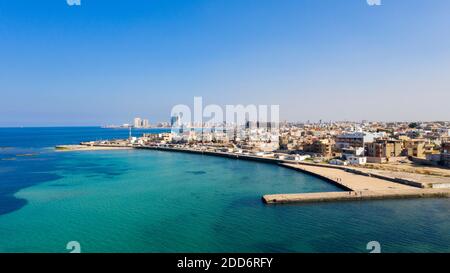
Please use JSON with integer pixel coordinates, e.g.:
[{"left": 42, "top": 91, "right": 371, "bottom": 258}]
[{"left": 107, "top": 119, "right": 450, "bottom": 167}]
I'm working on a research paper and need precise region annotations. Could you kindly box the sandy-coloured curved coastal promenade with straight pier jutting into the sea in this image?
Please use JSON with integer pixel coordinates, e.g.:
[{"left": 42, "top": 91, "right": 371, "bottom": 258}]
[{"left": 59, "top": 145, "right": 450, "bottom": 204}]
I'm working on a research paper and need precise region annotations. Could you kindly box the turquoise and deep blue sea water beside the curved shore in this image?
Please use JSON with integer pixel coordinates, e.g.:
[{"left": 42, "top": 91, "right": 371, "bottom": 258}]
[{"left": 0, "top": 128, "right": 450, "bottom": 252}]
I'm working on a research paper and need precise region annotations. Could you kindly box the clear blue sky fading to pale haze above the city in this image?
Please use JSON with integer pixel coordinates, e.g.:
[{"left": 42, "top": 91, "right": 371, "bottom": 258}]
[{"left": 0, "top": 0, "right": 450, "bottom": 126}]
